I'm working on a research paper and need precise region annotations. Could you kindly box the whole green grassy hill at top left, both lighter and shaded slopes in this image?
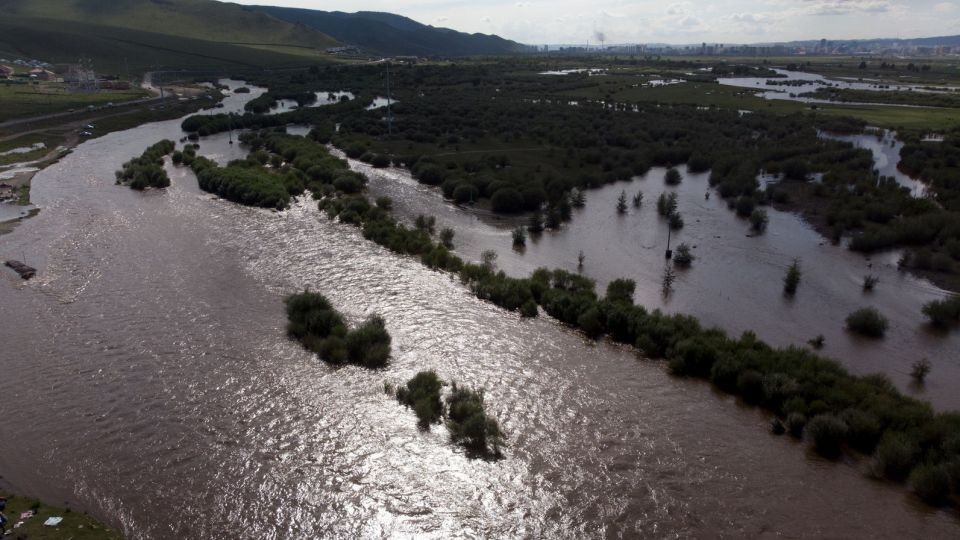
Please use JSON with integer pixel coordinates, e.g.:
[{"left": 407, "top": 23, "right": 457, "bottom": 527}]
[{"left": 0, "top": 0, "right": 337, "bottom": 73}]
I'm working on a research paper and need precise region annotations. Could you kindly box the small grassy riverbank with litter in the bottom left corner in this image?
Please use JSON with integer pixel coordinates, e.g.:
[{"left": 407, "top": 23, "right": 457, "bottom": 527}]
[{"left": 0, "top": 490, "right": 123, "bottom": 540}]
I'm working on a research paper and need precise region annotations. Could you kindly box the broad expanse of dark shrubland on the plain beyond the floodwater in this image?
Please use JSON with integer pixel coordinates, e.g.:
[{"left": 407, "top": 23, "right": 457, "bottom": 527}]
[{"left": 183, "top": 59, "right": 960, "bottom": 291}]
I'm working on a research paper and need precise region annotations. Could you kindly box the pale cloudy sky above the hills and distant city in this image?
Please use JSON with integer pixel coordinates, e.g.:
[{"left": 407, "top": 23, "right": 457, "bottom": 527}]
[{"left": 232, "top": 0, "right": 960, "bottom": 45}]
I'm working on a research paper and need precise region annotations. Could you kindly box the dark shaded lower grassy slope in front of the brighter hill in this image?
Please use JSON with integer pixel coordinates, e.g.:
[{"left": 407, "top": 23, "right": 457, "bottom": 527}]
[{"left": 0, "top": 17, "right": 326, "bottom": 74}]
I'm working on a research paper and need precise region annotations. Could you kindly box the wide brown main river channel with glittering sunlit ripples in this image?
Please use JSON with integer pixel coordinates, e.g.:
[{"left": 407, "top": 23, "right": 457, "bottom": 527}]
[{"left": 0, "top": 82, "right": 960, "bottom": 539}]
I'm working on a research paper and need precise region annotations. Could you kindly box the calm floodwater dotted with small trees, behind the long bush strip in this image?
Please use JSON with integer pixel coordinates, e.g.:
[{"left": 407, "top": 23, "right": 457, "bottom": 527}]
[{"left": 351, "top": 154, "right": 960, "bottom": 409}]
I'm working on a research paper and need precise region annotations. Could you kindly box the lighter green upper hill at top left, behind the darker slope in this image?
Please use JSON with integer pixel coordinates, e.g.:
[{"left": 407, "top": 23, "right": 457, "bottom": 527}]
[{"left": 0, "top": 0, "right": 336, "bottom": 49}]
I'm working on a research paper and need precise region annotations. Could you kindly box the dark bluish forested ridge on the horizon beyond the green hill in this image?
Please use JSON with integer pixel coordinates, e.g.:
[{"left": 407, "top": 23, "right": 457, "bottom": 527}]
[{"left": 253, "top": 6, "right": 531, "bottom": 56}]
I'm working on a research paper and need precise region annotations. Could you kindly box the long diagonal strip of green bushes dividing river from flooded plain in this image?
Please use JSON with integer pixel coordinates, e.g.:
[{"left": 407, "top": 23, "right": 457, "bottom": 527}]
[{"left": 176, "top": 132, "right": 960, "bottom": 505}]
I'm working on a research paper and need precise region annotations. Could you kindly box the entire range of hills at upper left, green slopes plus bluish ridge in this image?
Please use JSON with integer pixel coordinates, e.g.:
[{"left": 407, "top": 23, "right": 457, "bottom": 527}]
[{"left": 0, "top": 0, "right": 526, "bottom": 73}]
